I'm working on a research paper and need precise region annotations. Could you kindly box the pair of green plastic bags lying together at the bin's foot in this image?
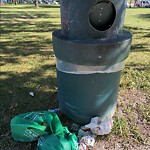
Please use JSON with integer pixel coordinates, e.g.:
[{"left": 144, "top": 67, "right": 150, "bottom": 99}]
[{"left": 11, "top": 111, "right": 78, "bottom": 150}]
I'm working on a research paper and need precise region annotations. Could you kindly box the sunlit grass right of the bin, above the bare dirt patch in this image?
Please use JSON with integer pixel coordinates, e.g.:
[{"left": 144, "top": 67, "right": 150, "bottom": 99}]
[{"left": 121, "top": 8, "right": 150, "bottom": 91}]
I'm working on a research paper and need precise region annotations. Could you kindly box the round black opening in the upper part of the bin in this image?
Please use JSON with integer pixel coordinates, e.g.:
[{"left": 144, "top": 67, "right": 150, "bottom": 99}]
[{"left": 89, "top": 1, "right": 116, "bottom": 31}]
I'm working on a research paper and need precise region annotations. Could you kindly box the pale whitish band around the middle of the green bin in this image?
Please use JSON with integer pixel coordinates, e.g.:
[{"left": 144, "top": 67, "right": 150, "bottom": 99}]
[{"left": 56, "top": 58, "right": 125, "bottom": 74}]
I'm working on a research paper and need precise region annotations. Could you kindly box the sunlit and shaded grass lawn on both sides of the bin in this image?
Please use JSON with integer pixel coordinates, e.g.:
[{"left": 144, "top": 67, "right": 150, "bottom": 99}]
[{"left": 0, "top": 5, "right": 150, "bottom": 149}]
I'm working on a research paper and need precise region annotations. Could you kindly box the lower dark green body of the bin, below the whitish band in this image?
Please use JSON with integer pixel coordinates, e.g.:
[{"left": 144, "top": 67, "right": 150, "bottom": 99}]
[{"left": 57, "top": 70, "right": 121, "bottom": 124}]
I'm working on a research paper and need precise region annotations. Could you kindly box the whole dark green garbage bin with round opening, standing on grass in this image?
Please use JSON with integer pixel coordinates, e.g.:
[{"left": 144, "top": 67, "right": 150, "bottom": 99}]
[{"left": 53, "top": 0, "right": 132, "bottom": 124}]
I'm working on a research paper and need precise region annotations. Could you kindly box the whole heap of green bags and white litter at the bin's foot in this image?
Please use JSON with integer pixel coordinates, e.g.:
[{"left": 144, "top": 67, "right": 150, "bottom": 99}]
[{"left": 10, "top": 108, "right": 113, "bottom": 150}]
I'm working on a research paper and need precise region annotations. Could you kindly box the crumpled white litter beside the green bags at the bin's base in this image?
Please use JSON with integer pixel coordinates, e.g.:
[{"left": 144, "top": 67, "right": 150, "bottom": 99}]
[{"left": 78, "top": 117, "right": 113, "bottom": 150}]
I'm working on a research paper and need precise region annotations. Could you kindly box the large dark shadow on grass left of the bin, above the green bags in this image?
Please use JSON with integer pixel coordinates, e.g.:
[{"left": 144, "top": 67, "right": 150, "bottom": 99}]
[{"left": 0, "top": 65, "right": 57, "bottom": 133}]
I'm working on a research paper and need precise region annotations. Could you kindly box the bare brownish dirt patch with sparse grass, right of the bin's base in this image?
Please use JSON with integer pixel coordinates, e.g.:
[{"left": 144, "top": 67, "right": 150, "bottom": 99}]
[{"left": 95, "top": 90, "right": 150, "bottom": 150}]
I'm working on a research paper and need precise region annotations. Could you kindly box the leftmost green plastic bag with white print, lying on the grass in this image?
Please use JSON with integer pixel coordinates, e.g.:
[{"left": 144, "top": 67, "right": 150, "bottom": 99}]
[{"left": 10, "top": 112, "right": 52, "bottom": 142}]
